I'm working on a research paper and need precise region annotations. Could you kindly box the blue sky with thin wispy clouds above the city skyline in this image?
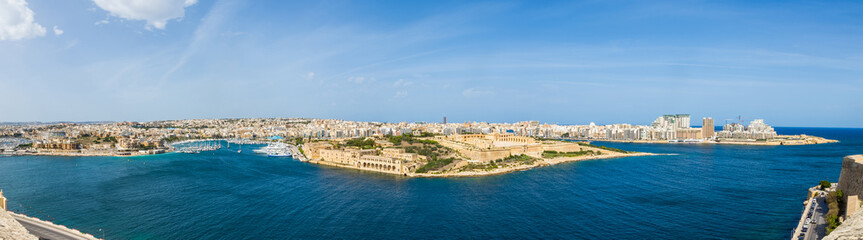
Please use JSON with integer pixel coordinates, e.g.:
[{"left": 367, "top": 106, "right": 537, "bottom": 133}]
[{"left": 0, "top": 0, "right": 863, "bottom": 127}]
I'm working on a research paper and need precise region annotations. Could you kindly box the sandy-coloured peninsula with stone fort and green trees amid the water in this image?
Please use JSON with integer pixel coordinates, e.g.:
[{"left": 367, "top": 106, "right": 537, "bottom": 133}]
[{"left": 302, "top": 133, "right": 653, "bottom": 177}]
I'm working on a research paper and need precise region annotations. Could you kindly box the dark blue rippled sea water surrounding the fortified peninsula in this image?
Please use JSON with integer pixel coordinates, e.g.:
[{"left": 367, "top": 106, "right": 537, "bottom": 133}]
[{"left": 0, "top": 128, "right": 863, "bottom": 239}]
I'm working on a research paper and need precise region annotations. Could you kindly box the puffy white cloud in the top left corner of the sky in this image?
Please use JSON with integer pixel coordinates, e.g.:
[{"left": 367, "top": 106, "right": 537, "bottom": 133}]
[{"left": 0, "top": 0, "right": 45, "bottom": 40}]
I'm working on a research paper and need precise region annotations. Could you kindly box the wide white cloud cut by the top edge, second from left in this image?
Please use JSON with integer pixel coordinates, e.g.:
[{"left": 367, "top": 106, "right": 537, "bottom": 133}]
[{"left": 93, "top": 0, "right": 198, "bottom": 29}]
